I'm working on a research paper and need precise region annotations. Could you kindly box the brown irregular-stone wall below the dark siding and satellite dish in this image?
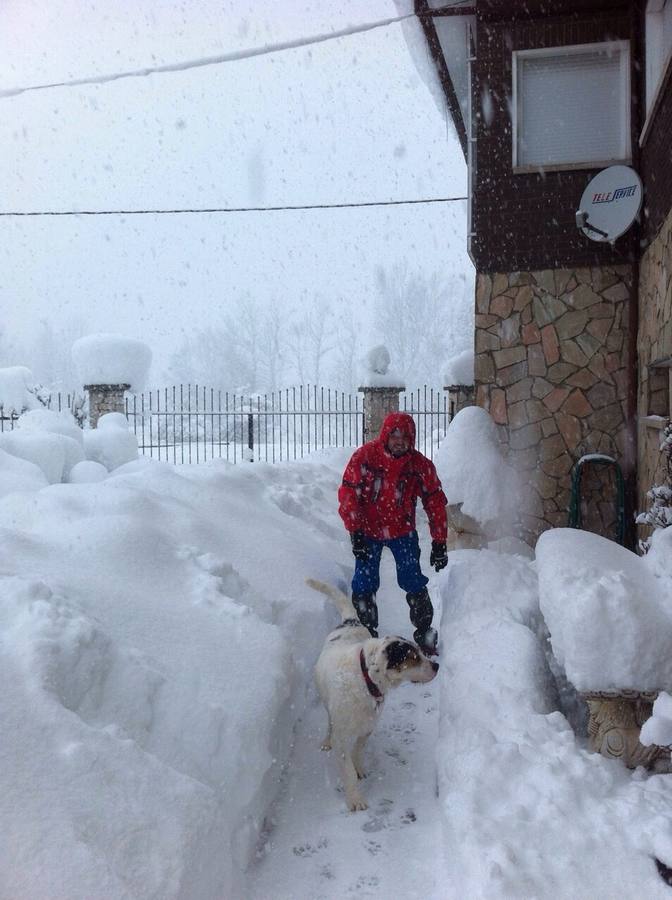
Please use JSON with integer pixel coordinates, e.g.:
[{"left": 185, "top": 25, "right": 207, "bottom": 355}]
[{"left": 475, "top": 265, "right": 632, "bottom": 543}]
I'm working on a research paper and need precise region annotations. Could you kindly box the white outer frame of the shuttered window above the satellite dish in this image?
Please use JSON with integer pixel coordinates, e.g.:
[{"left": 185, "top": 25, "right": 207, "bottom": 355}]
[{"left": 511, "top": 39, "right": 632, "bottom": 174}]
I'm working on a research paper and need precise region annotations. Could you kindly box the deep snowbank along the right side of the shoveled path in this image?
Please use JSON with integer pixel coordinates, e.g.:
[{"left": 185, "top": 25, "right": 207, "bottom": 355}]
[{"left": 437, "top": 544, "right": 672, "bottom": 900}]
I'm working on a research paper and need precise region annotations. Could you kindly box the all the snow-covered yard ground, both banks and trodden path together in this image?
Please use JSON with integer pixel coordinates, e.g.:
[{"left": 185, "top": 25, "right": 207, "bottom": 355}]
[{"left": 0, "top": 426, "right": 672, "bottom": 900}]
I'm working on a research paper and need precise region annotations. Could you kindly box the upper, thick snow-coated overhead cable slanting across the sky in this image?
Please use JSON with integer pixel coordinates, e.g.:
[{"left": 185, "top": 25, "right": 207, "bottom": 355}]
[{"left": 0, "top": 13, "right": 415, "bottom": 99}]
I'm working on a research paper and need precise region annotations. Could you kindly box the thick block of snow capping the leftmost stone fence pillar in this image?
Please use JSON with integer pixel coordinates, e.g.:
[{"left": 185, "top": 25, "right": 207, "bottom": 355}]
[{"left": 72, "top": 334, "right": 152, "bottom": 392}]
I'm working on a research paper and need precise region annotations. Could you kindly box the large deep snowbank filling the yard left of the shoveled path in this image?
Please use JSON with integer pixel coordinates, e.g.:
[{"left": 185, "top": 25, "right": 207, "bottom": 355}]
[{"left": 0, "top": 457, "right": 342, "bottom": 900}]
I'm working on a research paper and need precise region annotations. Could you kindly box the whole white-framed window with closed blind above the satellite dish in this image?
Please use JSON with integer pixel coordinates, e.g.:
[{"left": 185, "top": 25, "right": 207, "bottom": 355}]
[{"left": 513, "top": 40, "right": 632, "bottom": 171}]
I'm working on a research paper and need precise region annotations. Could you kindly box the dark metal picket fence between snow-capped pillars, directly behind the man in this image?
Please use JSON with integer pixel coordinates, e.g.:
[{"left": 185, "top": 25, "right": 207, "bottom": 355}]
[{"left": 126, "top": 385, "right": 450, "bottom": 464}]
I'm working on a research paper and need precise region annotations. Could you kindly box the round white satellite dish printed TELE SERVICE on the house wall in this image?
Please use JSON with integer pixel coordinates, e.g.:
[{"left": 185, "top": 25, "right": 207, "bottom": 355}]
[{"left": 576, "top": 166, "right": 643, "bottom": 243}]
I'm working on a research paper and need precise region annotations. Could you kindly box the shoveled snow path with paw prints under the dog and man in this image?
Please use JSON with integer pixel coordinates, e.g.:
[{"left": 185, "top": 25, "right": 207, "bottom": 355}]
[{"left": 246, "top": 548, "right": 451, "bottom": 900}]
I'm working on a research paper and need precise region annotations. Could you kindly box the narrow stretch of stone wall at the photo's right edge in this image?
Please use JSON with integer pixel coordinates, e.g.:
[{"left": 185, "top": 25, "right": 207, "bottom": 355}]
[{"left": 637, "top": 206, "right": 672, "bottom": 528}]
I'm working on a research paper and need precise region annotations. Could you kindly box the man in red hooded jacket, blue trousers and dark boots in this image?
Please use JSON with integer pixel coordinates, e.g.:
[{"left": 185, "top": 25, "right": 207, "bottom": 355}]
[{"left": 338, "top": 413, "right": 448, "bottom": 655}]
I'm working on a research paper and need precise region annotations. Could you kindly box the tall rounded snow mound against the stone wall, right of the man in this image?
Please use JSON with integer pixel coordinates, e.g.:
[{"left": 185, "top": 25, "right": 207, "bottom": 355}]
[{"left": 434, "top": 406, "right": 520, "bottom": 532}]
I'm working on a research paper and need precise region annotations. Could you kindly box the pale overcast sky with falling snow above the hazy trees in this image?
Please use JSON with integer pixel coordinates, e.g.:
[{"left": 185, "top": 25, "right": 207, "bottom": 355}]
[{"left": 0, "top": 0, "right": 471, "bottom": 378}]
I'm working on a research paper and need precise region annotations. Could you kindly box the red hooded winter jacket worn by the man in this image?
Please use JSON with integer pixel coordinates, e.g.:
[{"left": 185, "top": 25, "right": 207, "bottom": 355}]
[{"left": 338, "top": 413, "right": 448, "bottom": 541}]
